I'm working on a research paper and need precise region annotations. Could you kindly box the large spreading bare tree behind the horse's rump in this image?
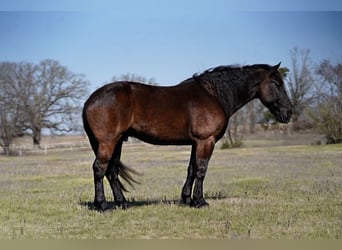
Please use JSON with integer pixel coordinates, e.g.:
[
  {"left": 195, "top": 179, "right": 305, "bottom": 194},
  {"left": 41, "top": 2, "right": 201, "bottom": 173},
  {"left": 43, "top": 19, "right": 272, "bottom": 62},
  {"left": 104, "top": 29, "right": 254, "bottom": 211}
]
[{"left": 1, "top": 59, "right": 88, "bottom": 146}]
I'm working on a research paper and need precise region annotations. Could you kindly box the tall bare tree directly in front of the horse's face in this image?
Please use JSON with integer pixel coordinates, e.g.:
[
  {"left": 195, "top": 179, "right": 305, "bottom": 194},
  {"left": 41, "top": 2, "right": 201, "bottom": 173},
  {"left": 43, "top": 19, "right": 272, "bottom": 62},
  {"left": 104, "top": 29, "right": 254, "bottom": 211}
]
[{"left": 286, "top": 47, "right": 313, "bottom": 122}]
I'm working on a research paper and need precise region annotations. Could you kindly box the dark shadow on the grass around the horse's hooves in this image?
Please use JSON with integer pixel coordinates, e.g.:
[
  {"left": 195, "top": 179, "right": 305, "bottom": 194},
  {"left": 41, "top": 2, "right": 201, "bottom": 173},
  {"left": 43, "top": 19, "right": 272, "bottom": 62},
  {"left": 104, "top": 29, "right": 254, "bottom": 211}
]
[{"left": 78, "top": 192, "right": 228, "bottom": 211}]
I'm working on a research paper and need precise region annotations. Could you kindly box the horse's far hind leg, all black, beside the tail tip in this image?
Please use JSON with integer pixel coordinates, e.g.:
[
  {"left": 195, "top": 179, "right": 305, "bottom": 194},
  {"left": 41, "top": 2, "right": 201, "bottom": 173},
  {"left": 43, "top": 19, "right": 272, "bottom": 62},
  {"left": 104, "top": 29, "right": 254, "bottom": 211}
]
[{"left": 106, "top": 139, "right": 128, "bottom": 209}]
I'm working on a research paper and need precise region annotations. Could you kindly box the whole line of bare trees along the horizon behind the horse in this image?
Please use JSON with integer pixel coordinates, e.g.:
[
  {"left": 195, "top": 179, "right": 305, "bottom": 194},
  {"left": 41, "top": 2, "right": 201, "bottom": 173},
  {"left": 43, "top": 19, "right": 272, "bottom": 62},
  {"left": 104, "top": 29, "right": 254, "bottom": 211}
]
[{"left": 0, "top": 47, "right": 342, "bottom": 154}]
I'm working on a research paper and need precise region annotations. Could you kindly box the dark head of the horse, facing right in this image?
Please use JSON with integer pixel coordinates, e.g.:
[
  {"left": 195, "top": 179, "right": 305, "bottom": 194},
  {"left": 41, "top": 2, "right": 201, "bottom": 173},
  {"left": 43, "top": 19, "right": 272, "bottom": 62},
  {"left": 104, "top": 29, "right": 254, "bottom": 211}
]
[{"left": 258, "top": 63, "right": 292, "bottom": 123}]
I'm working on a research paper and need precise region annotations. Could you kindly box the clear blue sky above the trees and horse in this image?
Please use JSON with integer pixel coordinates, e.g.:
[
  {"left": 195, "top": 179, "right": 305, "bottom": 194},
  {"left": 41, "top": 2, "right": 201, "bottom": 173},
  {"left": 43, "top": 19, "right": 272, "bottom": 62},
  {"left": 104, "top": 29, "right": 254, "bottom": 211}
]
[{"left": 0, "top": 0, "right": 342, "bottom": 91}]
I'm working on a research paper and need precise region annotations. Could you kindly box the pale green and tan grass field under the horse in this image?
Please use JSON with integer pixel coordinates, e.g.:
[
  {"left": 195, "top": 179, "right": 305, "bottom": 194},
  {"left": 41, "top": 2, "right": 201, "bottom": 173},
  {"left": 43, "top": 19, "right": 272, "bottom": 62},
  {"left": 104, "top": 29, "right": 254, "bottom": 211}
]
[{"left": 0, "top": 136, "right": 342, "bottom": 239}]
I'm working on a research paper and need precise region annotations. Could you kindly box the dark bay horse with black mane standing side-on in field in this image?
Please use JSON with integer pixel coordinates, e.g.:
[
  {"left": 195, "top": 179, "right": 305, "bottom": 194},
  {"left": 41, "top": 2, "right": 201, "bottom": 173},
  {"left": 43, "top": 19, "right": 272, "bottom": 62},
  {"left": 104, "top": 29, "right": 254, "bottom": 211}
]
[{"left": 82, "top": 63, "right": 292, "bottom": 211}]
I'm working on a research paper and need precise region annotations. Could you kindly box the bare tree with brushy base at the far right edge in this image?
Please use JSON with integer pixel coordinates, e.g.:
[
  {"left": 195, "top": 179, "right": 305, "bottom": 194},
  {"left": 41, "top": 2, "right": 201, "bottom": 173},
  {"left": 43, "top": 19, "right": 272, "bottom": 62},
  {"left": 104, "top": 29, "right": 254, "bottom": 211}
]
[{"left": 310, "top": 60, "right": 342, "bottom": 143}]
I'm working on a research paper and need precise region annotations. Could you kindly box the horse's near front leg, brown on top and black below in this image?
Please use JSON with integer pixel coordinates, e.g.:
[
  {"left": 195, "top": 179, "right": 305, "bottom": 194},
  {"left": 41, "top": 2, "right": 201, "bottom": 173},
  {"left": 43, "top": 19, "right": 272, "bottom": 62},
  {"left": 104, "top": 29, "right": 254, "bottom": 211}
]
[{"left": 191, "top": 137, "right": 215, "bottom": 208}]
